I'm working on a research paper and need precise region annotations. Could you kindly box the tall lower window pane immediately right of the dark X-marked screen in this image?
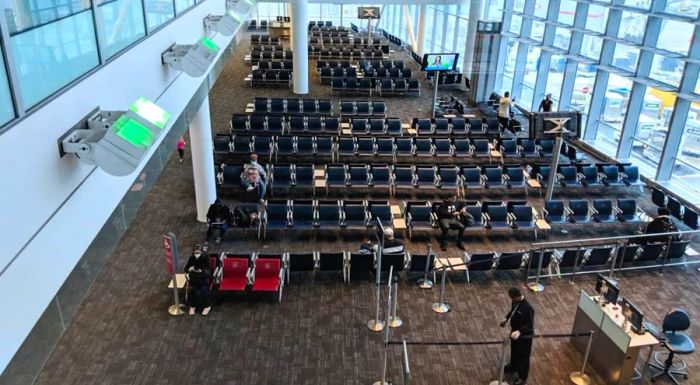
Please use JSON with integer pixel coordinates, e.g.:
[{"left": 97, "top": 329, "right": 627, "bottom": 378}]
[{"left": 595, "top": 74, "right": 632, "bottom": 156}]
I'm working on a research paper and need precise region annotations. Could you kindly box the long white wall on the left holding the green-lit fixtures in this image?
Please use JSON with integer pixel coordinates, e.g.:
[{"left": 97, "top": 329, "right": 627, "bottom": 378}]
[{"left": 0, "top": 0, "right": 238, "bottom": 373}]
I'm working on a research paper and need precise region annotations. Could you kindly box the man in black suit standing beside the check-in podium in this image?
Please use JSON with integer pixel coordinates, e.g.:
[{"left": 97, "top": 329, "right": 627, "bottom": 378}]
[{"left": 501, "top": 287, "right": 535, "bottom": 385}]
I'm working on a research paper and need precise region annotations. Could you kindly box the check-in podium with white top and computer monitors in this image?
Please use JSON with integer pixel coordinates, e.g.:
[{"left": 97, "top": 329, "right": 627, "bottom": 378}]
[{"left": 571, "top": 290, "right": 659, "bottom": 385}]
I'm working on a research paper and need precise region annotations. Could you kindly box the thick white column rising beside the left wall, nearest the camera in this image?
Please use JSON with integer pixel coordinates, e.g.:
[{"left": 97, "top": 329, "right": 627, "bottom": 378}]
[{"left": 190, "top": 95, "right": 216, "bottom": 222}]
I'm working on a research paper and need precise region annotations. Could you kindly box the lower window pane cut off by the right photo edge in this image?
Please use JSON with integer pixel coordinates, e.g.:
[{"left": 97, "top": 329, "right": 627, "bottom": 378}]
[{"left": 671, "top": 103, "right": 700, "bottom": 204}]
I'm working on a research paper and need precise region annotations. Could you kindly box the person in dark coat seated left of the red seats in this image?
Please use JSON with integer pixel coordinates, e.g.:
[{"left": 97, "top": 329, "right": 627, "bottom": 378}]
[{"left": 185, "top": 246, "right": 212, "bottom": 315}]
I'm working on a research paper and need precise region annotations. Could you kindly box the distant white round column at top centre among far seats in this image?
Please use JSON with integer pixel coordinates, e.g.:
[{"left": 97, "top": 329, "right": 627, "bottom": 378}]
[{"left": 291, "top": 0, "right": 309, "bottom": 95}]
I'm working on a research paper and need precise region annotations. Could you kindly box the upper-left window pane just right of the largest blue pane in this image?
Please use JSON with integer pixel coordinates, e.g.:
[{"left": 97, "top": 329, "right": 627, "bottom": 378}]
[{"left": 97, "top": 0, "right": 146, "bottom": 59}]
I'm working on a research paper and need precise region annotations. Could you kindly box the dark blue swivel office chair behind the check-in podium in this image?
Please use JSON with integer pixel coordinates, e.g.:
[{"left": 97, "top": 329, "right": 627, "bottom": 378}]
[{"left": 649, "top": 309, "right": 695, "bottom": 385}]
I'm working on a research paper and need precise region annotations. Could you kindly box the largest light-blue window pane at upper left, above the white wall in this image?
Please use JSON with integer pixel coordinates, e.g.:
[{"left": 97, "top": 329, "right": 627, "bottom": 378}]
[{"left": 10, "top": 10, "right": 98, "bottom": 108}]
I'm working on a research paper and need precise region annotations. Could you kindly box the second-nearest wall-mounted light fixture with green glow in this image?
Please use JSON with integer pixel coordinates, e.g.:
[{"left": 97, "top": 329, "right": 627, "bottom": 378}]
[{"left": 161, "top": 36, "right": 219, "bottom": 78}]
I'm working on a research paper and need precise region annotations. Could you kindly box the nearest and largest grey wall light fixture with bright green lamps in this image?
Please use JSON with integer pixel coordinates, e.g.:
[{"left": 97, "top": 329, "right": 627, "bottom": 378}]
[{"left": 59, "top": 97, "right": 171, "bottom": 176}]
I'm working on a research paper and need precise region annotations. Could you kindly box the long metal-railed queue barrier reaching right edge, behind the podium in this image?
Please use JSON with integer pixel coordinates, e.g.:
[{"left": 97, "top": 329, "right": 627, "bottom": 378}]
[{"left": 525, "top": 230, "right": 700, "bottom": 292}]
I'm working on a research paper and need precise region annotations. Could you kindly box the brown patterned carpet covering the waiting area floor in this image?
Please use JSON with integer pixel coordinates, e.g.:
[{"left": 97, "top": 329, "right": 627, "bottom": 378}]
[{"left": 31, "top": 32, "right": 700, "bottom": 385}]
